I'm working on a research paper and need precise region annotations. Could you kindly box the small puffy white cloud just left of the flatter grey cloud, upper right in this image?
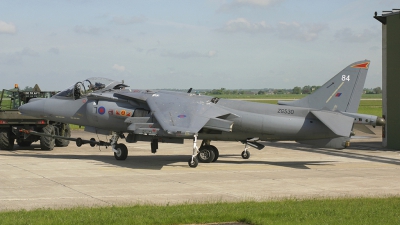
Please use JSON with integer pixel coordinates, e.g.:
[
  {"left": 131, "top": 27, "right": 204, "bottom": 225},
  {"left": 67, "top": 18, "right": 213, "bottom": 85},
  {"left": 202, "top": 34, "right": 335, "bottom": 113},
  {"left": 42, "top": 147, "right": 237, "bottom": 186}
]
[{"left": 219, "top": 18, "right": 271, "bottom": 33}]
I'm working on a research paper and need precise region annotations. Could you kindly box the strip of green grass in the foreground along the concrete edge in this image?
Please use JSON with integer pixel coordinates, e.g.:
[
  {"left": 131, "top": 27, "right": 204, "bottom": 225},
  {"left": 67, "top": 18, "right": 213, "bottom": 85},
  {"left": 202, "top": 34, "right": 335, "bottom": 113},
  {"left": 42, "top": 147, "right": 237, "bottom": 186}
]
[{"left": 0, "top": 197, "right": 400, "bottom": 225}]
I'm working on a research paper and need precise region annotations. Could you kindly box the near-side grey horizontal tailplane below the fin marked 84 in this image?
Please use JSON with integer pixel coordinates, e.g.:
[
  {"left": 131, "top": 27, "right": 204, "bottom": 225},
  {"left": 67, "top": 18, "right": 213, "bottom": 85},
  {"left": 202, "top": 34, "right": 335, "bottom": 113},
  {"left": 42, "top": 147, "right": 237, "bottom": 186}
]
[{"left": 311, "top": 111, "right": 353, "bottom": 137}]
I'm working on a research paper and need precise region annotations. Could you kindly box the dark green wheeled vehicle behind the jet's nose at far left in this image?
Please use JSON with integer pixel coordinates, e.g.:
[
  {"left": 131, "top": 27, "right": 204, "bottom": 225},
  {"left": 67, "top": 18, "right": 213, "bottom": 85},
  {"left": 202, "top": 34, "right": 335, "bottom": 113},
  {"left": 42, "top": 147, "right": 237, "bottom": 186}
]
[{"left": 0, "top": 85, "right": 71, "bottom": 150}]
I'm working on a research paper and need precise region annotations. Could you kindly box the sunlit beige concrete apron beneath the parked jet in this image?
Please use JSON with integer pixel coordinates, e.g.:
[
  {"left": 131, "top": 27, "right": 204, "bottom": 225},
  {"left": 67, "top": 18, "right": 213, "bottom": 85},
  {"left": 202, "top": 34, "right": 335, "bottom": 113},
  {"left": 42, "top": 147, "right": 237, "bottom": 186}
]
[{"left": 0, "top": 127, "right": 400, "bottom": 211}]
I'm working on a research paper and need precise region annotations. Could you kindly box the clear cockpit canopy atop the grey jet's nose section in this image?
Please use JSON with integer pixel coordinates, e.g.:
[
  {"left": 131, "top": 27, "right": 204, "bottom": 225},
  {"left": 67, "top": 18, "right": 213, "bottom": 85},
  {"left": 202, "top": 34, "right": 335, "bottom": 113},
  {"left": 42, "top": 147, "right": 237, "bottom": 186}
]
[{"left": 55, "top": 77, "right": 129, "bottom": 99}]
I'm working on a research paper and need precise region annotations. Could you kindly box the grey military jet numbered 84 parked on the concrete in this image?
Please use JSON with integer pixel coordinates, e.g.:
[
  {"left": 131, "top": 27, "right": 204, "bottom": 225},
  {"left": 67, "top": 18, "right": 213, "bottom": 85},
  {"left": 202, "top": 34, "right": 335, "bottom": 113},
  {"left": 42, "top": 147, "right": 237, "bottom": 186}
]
[{"left": 20, "top": 60, "right": 385, "bottom": 167}]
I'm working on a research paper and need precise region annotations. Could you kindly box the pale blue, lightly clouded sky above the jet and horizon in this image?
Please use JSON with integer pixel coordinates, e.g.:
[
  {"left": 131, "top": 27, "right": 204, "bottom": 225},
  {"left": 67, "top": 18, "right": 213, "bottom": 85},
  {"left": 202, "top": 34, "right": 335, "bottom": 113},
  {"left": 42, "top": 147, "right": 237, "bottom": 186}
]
[{"left": 0, "top": 0, "right": 400, "bottom": 90}]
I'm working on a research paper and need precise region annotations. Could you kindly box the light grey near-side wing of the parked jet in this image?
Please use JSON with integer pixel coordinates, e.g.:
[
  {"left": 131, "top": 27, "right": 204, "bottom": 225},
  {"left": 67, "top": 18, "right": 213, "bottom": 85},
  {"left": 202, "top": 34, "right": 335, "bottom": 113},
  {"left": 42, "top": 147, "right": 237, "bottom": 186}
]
[{"left": 117, "top": 92, "right": 238, "bottom": 136}]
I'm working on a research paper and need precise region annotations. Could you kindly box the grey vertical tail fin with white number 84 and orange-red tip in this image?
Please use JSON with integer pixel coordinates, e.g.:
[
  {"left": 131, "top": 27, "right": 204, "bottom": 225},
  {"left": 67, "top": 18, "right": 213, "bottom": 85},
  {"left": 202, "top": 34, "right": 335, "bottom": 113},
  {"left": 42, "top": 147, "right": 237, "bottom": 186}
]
[{"left": 278, "top": 60, "right": 370, "bottom": 113}]
